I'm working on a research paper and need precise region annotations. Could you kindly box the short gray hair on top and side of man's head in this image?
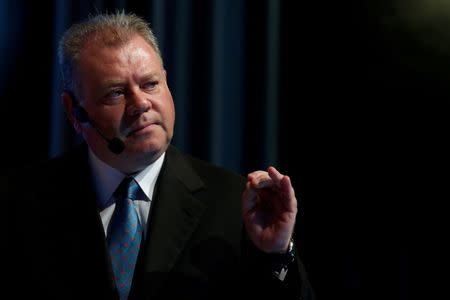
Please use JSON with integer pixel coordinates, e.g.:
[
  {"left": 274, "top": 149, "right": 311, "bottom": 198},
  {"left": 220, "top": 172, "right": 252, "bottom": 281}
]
[{"left": 58, "top": 11, "right": 163, "bottom": 94}]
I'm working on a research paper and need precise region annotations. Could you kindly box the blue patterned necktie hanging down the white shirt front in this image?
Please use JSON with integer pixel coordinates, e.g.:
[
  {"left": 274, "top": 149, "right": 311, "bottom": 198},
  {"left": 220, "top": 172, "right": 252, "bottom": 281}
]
[{"left": 107, "top": 177, "right": 142, "bottom": 300}]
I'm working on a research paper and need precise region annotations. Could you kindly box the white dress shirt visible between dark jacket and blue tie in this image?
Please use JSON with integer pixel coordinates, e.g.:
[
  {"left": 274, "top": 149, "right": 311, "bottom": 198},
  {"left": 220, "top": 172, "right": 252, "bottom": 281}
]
[{"left": 89, "top": 149, "right": 165, "bottom": 238}]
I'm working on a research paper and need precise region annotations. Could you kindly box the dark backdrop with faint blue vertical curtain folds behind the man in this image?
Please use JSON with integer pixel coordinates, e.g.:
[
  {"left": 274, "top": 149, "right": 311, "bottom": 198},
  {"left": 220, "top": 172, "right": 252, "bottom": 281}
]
[{"left": 0, "top": 0, "right": 442, "bottom": 299}]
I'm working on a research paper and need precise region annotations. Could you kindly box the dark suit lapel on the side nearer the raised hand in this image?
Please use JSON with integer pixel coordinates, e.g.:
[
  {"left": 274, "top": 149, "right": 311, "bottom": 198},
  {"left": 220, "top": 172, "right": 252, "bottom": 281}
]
[{"left": 139, "top": 147, "right": 205, "bottom": 288}]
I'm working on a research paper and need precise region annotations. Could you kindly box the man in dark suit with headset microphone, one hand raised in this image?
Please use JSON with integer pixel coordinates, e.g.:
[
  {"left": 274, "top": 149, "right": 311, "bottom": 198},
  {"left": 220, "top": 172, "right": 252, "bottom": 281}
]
[{"left": 5, "top": 13, "right": 311, "bottom": 299}]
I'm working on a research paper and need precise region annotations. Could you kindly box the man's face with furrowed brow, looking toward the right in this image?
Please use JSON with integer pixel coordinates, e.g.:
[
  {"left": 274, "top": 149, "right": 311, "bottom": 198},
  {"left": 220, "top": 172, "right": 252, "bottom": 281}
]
[{"left": 73, "top": 35, "right": 175, "bottom": 173}]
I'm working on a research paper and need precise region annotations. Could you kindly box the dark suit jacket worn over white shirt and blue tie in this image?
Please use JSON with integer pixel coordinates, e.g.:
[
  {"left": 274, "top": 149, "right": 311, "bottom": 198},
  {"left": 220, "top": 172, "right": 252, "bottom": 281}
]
[{"left": 0, "top": 145, "right": 311, "bottom": 300}]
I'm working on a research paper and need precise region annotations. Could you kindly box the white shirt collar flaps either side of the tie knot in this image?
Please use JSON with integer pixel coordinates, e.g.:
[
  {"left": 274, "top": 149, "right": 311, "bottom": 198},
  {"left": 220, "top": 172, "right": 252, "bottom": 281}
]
[{"left": 89, "top": 149, "right": 166, "bottom": 209}]
